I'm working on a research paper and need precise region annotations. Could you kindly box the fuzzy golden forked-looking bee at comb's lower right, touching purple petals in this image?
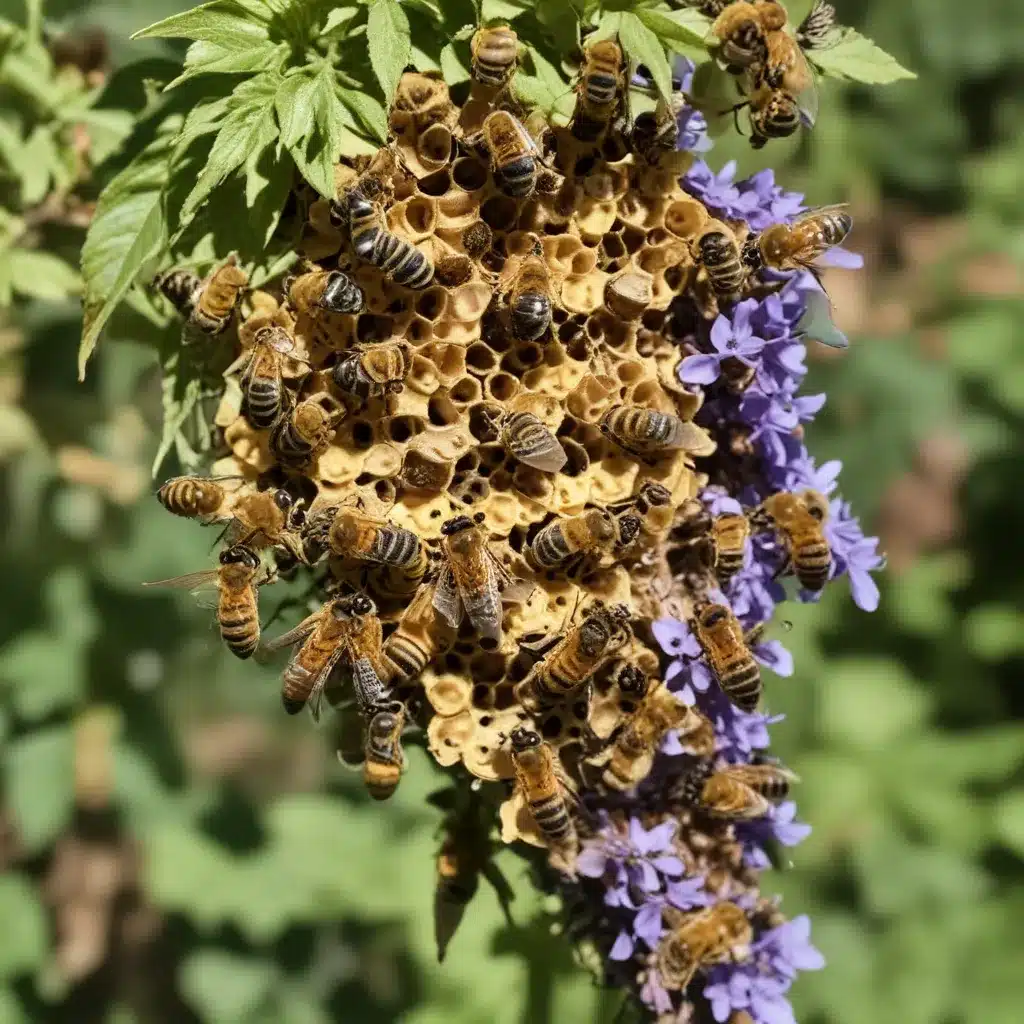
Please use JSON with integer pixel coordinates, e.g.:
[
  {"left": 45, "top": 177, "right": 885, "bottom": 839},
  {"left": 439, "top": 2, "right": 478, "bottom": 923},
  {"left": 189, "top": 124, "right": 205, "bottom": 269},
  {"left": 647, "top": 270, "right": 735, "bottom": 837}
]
[{"left": 602, "top": 673, "right": 715, "bottom": 790}]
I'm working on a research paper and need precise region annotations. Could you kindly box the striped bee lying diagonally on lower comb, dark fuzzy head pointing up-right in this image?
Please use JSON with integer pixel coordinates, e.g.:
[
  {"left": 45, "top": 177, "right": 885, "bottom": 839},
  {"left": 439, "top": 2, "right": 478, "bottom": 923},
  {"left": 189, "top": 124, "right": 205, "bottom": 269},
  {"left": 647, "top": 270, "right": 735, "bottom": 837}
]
[{"left": 521, "top": 604, "right": 632, "bottom": 712}]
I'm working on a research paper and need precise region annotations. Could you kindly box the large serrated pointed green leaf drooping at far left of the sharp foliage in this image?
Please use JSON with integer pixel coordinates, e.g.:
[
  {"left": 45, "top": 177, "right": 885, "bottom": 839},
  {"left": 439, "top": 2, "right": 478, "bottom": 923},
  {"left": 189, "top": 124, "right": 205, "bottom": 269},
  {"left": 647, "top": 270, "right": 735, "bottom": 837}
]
[{"left": 78, "top": 120, "right": 173, "bottom": 378}]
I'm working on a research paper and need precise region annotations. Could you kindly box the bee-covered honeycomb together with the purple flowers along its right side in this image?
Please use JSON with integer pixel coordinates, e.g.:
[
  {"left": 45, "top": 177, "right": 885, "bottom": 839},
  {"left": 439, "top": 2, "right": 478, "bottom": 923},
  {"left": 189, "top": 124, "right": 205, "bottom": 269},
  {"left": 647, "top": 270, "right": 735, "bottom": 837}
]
[{"left": 149, "top": 4, "right": 878, "bottom": 1019}]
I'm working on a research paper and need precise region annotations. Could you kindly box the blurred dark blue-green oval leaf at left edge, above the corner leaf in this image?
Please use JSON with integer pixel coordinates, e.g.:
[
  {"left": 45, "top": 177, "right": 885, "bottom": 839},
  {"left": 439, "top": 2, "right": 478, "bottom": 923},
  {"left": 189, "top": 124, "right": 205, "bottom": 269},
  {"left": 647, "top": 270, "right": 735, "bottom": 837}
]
[{"left": 4, "top": 725, "right": 75, "bottom": 853}]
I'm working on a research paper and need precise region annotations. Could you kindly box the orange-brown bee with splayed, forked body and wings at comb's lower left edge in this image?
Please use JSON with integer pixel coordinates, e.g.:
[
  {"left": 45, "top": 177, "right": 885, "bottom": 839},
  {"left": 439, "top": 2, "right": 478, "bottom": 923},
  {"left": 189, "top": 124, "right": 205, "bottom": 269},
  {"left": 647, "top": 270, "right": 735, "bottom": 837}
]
[{"left": 265, "top": 594, "right": 387, "bottom": 721}]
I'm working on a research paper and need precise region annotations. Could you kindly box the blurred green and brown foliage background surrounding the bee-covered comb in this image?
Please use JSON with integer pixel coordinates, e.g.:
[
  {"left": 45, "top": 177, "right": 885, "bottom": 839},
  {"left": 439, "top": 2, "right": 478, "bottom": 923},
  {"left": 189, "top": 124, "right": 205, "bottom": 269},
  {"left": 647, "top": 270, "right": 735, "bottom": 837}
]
[{"left": 0, "top": 0, "right": 1024, "bottom": 1024}]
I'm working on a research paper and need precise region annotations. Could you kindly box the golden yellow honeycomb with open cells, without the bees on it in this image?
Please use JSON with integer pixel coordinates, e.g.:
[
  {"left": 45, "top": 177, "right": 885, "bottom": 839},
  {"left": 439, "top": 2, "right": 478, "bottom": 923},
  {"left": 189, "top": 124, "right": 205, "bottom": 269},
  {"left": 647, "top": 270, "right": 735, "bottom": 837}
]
[{"left": 163, "top": 66, "right": 742, "bottom": 864}]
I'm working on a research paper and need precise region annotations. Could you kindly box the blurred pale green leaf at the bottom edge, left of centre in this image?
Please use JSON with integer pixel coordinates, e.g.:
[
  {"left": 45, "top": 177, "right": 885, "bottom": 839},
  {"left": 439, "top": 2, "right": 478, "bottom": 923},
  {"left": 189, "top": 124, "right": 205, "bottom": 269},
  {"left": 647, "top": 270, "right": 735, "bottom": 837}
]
[{"left": 181, "top": 949, "right": 275, "bottom": 1024}]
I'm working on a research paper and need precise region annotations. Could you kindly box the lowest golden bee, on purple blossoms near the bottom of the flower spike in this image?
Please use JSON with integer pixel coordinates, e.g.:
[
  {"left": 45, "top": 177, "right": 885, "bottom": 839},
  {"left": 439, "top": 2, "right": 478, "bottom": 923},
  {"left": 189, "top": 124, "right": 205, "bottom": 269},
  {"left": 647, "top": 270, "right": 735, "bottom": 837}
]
[{"left": 655, "top": 900, "right": 754, "bottom": 991}]
